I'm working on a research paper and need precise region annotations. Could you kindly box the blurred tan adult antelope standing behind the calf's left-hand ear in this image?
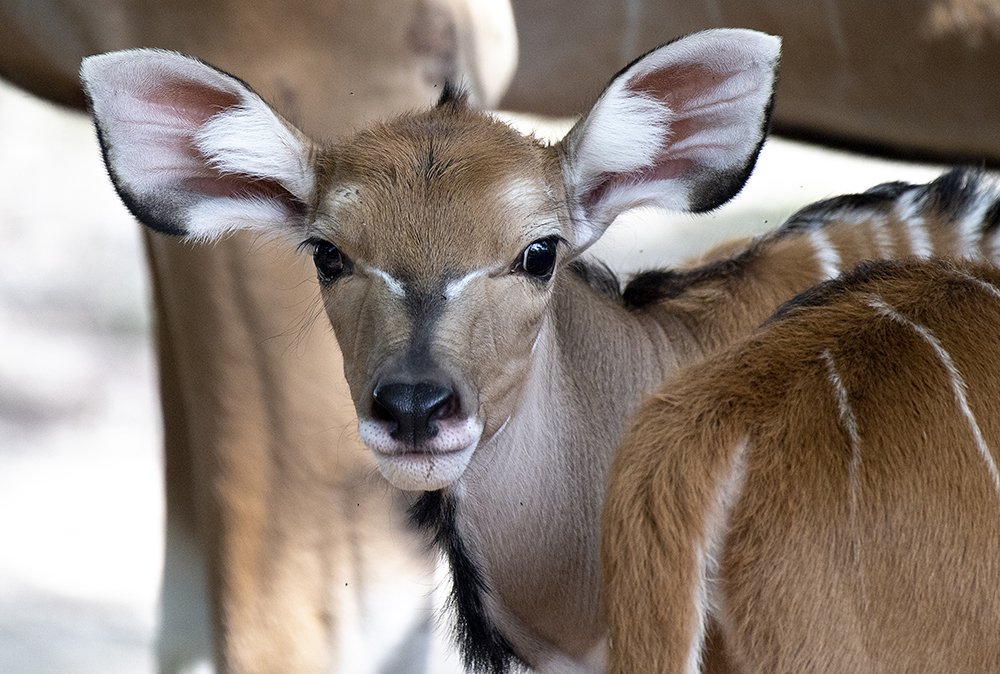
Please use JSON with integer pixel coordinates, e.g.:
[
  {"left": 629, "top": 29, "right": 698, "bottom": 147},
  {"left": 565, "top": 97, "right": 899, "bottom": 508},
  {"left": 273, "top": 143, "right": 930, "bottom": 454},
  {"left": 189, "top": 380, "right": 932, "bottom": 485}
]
[{"left": 0, "top": 0, "right": 516, "bottom": 674}]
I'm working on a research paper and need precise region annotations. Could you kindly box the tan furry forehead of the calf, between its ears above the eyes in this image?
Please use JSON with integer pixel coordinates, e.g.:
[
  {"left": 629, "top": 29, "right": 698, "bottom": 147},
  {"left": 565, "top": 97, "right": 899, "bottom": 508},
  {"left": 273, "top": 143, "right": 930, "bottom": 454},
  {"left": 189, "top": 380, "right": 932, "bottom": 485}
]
[{"left": 312, "top": 111, "right": 561, "bottom": 270}]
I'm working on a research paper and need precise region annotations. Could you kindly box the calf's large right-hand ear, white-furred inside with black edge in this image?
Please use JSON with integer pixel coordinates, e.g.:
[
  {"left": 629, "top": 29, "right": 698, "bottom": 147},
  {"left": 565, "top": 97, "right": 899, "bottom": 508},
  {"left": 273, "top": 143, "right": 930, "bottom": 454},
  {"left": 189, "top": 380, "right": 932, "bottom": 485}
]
[{"left": 561, "top": 29, "right": 781, "bottom": 248}]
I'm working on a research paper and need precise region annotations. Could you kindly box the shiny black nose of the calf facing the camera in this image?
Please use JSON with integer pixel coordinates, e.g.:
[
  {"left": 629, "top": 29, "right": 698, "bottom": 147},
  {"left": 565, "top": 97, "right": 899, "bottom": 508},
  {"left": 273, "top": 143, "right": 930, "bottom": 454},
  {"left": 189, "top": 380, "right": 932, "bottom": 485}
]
[{"left": 372, "top": 382, "right": 457, "bottom": 445}]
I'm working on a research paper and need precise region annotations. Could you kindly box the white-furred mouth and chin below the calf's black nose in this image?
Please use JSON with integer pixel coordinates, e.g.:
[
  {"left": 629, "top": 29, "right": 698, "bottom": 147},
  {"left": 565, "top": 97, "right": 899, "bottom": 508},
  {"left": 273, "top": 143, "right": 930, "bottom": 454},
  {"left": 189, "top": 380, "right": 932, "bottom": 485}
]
[{"left": 358, "top": 419, "right": 483, "bottom": 491}]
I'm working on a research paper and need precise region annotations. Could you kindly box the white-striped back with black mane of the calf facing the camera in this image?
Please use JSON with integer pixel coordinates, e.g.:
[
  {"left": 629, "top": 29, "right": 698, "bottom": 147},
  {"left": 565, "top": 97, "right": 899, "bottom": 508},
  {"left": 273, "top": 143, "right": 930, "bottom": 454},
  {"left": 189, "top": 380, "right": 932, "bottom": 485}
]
[{"left": 623, "top": 169, "right": 1000, "bottom": 356}]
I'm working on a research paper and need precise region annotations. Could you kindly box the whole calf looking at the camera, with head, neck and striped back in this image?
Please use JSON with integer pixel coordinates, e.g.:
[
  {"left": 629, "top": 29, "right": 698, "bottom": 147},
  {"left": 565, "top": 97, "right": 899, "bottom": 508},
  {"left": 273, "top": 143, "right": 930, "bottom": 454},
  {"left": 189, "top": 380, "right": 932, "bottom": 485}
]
[{"left": 82, "top": 30, "right": 993, "bottom": 673}]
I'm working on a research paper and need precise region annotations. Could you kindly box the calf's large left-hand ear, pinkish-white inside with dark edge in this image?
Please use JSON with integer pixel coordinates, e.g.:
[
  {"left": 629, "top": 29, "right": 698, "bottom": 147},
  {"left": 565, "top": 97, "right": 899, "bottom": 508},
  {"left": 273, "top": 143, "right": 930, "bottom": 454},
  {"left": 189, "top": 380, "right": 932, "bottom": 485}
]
[{"left": 80, "top": 49, "right": 316, "bottom": 239}]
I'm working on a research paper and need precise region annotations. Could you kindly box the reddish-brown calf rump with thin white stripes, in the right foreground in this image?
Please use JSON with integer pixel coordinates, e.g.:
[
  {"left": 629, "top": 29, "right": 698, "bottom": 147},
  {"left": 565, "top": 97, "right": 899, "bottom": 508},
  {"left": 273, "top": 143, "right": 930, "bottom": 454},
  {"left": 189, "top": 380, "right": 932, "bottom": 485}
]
[{"left": 603, "top": 255, "right": 1000, "bottom": 674}]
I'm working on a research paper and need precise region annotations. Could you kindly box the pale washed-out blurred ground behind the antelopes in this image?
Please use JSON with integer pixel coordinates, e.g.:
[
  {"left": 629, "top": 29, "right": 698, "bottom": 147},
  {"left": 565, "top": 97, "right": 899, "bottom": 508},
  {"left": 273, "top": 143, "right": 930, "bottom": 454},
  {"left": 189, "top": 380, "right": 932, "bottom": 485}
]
[{"left": 0, "top": 75, "right": 938, "bottom": 674}]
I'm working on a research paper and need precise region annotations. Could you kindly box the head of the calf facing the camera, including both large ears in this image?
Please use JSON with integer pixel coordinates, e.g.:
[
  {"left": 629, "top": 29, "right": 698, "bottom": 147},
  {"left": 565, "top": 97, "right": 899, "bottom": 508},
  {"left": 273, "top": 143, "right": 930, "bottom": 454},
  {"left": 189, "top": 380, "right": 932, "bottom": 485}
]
[{"left": 82, "top": 30, "right": 780, "bottom": 490}]
